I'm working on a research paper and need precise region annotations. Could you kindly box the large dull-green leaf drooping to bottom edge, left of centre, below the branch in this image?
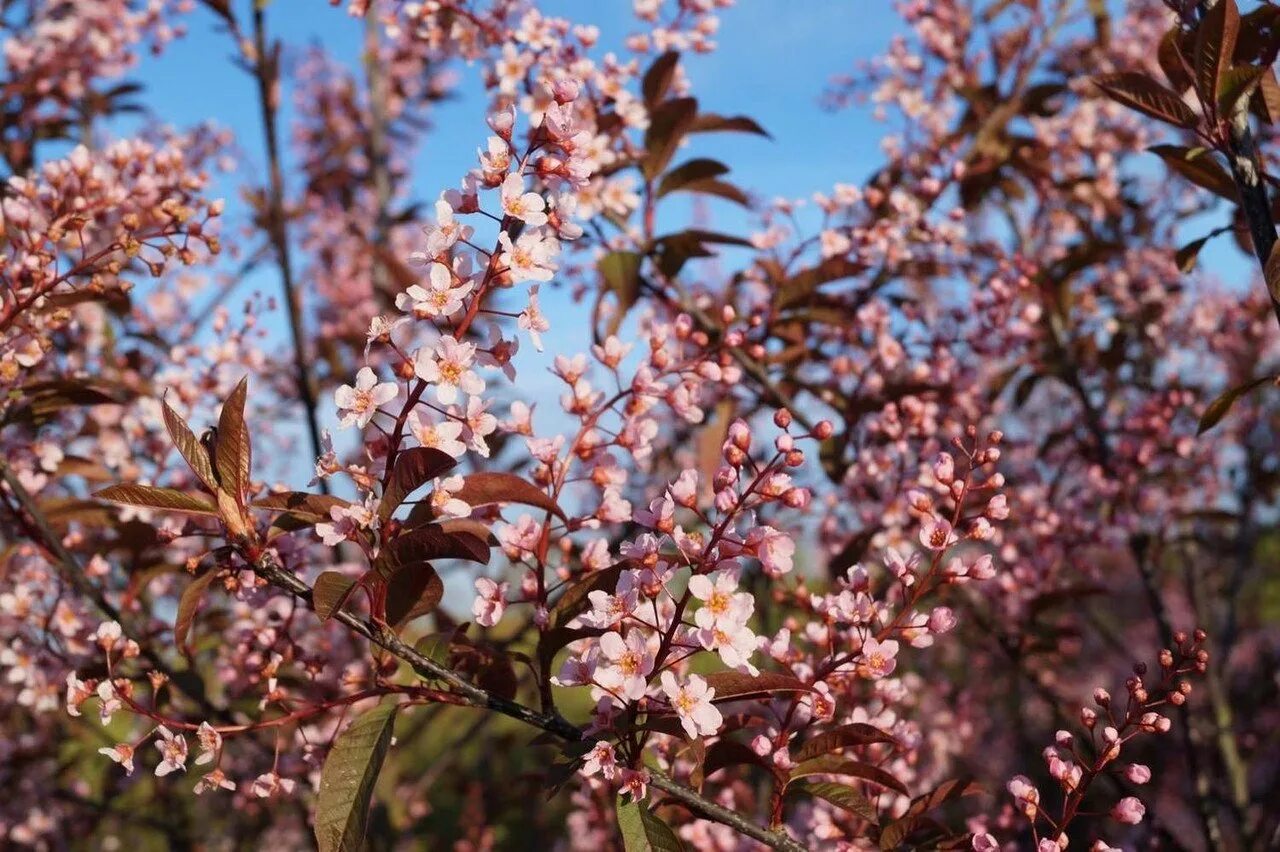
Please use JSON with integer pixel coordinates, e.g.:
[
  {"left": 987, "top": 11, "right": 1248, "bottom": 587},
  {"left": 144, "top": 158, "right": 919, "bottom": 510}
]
[{"left": 315, "top": 704, "right": 397, "bottom": 852}]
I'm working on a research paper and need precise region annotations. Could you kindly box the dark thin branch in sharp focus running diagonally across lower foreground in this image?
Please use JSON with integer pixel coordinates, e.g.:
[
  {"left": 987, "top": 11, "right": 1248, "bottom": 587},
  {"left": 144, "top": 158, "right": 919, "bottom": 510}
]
[{"left": 252, "top": 550, "right": 805, "bottom": 852}]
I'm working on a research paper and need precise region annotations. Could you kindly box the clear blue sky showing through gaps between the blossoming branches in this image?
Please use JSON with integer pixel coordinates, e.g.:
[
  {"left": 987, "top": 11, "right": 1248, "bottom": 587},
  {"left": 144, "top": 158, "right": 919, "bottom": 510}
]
[{"left": 115, "top": 0, "right": 902, "bottom": 460}]
